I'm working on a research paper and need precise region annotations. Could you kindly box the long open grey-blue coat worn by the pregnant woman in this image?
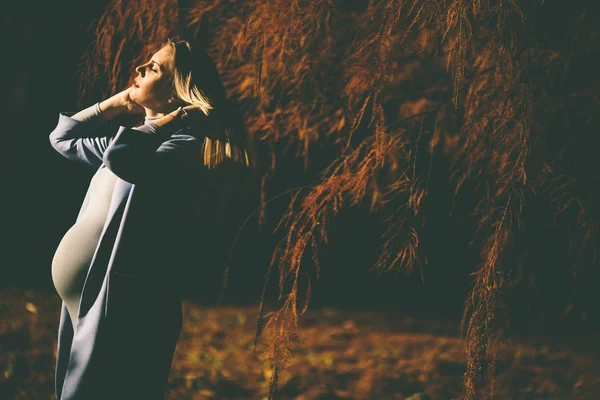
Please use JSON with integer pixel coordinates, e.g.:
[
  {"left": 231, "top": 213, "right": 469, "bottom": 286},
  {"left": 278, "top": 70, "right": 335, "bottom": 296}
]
[{"left": 50, "top": 113, "right": 204, "bottom": 400}]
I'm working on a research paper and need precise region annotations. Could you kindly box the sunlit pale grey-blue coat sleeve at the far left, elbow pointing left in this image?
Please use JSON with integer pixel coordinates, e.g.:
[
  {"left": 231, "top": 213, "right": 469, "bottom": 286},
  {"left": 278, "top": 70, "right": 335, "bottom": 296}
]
[{"left": 49, "top": 113, "right": 112, "bottom": 168}]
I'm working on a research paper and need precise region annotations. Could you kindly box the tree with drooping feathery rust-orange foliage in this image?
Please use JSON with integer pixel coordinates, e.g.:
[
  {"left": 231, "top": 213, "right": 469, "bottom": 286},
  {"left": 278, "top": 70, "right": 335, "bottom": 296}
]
[{"left": 81, "top": 0, "right": 600, "bottom": 399}]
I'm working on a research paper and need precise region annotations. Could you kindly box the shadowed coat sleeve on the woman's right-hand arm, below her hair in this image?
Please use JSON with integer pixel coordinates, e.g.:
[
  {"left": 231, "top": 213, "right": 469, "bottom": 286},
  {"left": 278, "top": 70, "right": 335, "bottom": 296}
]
[{"left": 103, "top": 125, "right": 204, "bottom": 184}]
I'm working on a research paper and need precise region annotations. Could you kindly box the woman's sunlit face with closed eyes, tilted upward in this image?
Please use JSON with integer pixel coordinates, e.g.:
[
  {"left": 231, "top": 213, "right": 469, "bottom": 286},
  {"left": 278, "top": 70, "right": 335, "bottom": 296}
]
[{"left": 129, "top": 46, "right": 173, "bottom": 112}]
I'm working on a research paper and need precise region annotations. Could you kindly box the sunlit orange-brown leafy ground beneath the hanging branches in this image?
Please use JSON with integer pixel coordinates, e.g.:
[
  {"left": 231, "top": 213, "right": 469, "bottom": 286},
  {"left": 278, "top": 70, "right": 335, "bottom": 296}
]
[{"left": 0, "top": 288, "right": 600, "bottom": 400}]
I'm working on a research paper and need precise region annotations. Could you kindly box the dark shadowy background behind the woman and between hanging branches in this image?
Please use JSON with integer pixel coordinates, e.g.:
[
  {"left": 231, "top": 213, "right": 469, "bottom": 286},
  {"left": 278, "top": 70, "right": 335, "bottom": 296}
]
[{"left": 0, "top": 0, "right": 596, "bottom": 334}]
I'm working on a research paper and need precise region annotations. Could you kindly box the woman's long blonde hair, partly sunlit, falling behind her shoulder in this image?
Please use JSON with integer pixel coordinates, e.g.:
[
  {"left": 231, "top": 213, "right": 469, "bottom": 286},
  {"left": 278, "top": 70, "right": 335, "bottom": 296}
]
[{"left": 166, "top": 39, "right": 254, "bottom": 168}]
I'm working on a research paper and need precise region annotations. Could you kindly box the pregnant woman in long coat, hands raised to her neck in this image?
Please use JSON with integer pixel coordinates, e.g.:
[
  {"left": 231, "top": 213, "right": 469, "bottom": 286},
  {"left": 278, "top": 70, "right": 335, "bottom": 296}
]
[{"left": 50, "top": 39, "right": 252, "bottom": 400}]
